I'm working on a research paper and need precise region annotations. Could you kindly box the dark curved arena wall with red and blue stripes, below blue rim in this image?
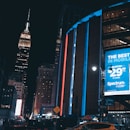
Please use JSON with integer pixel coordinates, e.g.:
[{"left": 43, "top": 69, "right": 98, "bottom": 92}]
[{"left": 61, "top": 12, "right": 101, "bottom": 116}]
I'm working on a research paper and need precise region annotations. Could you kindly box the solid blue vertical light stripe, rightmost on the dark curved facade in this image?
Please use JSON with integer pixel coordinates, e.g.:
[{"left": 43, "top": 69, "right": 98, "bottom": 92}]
[{"left": 81, "top": 22, "right": 89, "bottom": 116}]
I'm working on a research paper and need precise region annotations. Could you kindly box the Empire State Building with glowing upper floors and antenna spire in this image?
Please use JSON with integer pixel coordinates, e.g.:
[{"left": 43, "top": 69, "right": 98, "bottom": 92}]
[{"left": 15, "top": 10, "right": 31, "bottom": 88}]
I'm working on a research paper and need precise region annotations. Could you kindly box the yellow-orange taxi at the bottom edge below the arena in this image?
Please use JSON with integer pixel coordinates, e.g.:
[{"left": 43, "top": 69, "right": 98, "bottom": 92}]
[{"left": 71, "top": 122, "right": 117, "bottom": 130}]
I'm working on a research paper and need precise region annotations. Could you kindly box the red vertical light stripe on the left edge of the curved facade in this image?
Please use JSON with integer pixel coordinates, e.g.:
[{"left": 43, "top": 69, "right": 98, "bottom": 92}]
[{"left": 60, "top": 34, "right": 68, "bottom": 116}]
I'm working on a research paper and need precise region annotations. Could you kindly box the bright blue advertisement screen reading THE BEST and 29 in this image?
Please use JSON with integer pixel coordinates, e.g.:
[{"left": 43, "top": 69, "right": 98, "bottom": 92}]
[{"left": 104, "top": 48, "right": 130, "bottom": 96}]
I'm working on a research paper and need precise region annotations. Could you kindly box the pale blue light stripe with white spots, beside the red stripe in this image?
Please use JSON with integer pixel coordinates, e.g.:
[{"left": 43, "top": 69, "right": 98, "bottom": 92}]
[{"left": 69, "top": 29, "right": 77, "bottom": 115}]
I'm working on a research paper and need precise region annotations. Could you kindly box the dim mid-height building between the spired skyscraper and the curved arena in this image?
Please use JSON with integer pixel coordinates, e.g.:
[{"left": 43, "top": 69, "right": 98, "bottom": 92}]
[{"left": 33, "top": 64, "right": 56, "bottom": 115}]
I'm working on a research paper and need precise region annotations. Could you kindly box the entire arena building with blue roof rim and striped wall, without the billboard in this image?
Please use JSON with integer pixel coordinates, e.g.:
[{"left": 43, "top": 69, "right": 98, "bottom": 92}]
[{"left": 60, "top": 1, "right": 130, "bottom": 116}]
